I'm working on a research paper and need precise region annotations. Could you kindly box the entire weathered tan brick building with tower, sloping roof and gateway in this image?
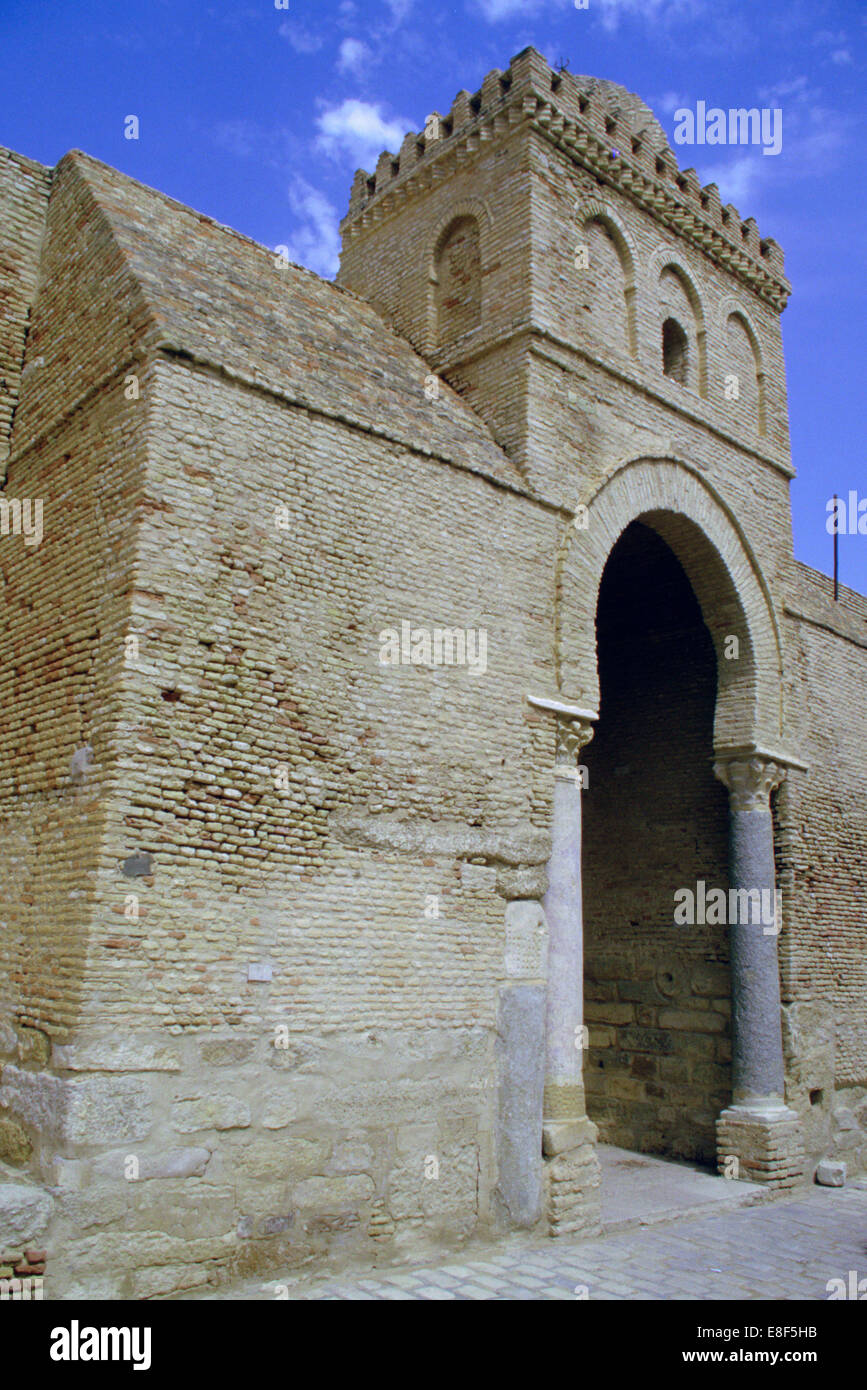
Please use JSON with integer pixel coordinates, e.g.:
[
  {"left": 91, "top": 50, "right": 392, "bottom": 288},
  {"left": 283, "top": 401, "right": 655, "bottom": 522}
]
[{"left": 0, "top": 50, "right": 867, "bottom": 1297}]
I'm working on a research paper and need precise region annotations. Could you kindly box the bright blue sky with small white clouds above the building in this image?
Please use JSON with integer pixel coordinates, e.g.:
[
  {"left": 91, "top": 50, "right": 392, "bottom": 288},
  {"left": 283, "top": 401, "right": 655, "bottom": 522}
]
[{"left": 0, "top": 0, "right": 867, "bottom": 592}]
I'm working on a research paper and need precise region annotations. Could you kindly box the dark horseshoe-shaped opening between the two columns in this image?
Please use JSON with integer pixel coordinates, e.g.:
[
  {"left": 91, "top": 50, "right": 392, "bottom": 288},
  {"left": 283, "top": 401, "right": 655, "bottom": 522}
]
[{"left": 584, "top": 521, "right": 731, "bottom": 1163}]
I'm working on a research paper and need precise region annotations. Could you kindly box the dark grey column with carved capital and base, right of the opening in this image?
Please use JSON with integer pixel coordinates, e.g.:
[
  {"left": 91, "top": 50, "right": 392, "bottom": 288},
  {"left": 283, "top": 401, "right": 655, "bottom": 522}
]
[{"left": 714, "top": 753, "right": 804, "bottom": 1187}]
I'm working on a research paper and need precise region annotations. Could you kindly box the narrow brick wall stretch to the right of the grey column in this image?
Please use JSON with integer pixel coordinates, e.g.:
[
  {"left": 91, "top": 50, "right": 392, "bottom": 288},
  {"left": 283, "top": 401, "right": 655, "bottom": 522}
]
[{"left": 777, "top": 564, "right": 867, "bottom": 1172}]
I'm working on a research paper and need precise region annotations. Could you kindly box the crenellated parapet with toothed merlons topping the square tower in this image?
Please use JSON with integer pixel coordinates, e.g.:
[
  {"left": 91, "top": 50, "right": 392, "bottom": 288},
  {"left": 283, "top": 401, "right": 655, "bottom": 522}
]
[{"left": 342, "top": 49, "right": 791, "bottom": 311}]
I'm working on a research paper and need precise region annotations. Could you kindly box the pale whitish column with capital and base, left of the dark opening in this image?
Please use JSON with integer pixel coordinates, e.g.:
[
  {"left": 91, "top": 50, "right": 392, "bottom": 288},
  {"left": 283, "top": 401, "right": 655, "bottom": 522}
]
[{"left": 534, "top": 702, "right": 602, "bottom": 1236}]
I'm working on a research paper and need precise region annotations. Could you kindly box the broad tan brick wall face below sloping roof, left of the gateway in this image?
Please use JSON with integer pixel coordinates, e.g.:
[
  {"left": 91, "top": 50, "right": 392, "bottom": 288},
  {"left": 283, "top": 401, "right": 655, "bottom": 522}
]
[{"left": 33, "top": 353, "right": 552, "bottom": 1289}]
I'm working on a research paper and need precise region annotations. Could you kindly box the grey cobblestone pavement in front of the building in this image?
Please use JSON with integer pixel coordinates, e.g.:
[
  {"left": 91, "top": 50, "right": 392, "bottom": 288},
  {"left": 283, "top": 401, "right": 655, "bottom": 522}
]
[{"left": 219, "top": 1179, "right": 867, "bottom": 1300}]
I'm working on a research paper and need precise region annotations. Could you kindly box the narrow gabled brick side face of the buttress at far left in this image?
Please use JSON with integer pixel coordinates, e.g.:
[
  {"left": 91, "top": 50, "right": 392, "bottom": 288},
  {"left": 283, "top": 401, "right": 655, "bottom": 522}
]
[{"left": 0, "top": 152, "right": 143, "bottom": 1037}]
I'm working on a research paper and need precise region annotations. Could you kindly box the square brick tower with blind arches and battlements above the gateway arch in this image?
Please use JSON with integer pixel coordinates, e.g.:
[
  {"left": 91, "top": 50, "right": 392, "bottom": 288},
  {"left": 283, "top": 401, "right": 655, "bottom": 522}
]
[{"left": 338, "top": 49, "right": 791, "bottom": 555}]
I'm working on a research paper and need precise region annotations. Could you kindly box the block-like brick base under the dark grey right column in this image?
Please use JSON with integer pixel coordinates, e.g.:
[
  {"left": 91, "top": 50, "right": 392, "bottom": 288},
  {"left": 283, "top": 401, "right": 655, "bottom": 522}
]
[{"left": 717, "top": 1101, "right": 804, "bottom": 1188}]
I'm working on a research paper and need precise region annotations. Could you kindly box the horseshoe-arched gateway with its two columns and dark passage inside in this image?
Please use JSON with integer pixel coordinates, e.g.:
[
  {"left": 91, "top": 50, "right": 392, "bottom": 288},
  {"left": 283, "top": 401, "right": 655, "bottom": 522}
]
[{"left": 531, "top": 457, "right": 803, "bottom": 1230}]
